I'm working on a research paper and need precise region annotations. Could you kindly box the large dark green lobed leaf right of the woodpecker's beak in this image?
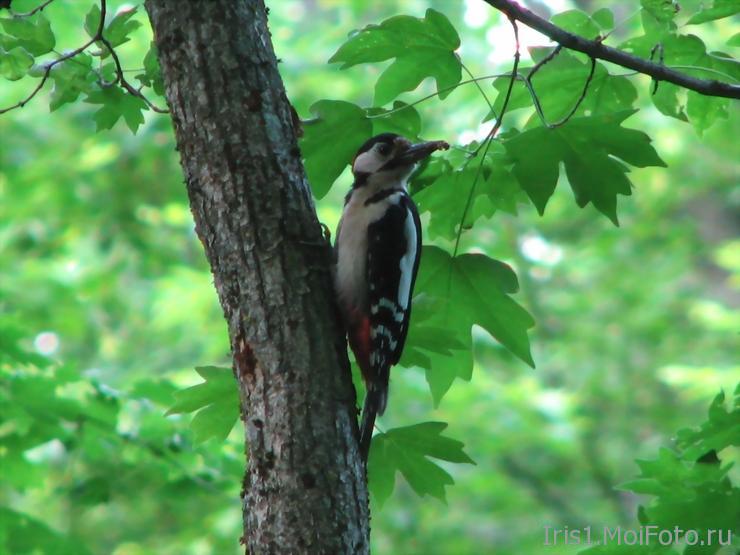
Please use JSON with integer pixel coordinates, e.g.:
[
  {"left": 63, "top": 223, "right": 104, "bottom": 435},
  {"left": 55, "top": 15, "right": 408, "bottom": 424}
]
[{"left": 504, "top": 111, "right": 665, "bottom": 225}]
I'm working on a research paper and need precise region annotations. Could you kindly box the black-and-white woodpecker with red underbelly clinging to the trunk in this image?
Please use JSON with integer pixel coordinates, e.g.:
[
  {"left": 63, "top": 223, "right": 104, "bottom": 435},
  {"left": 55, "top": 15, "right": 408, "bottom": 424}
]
[{"left": 335, "top": 133, "right": 449, "bottom": 461}]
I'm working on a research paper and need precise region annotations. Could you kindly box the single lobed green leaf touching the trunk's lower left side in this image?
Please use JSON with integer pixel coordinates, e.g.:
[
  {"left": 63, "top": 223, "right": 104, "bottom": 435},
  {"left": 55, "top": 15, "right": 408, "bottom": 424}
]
[{"left": 166, "top": 366, "right": 239, "bottom": 443}]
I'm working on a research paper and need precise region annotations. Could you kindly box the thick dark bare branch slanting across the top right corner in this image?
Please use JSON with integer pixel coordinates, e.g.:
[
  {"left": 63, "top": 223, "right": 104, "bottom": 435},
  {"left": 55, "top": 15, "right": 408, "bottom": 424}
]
[{"left": 483, "top": 0, "right": 740, "bottom": 99}]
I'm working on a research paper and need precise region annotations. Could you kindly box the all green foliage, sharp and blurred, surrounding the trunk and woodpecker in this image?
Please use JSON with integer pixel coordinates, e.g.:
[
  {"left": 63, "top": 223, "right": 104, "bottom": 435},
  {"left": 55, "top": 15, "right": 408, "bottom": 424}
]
[{"left": 0, "top": 0, "right": 740, "bottom": 555}]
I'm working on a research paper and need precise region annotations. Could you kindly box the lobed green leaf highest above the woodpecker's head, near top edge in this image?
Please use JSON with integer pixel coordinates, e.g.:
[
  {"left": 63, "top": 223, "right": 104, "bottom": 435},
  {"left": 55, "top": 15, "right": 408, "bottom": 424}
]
[{"left": 329, "top": 8, "right": 462, "bottom": 106}]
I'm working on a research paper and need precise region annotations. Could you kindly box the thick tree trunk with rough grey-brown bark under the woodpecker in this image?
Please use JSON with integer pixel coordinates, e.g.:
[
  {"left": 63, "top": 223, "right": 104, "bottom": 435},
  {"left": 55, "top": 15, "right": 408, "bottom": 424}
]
[{"left": 146, "top": 0, "right": 369, "bottom": 554}]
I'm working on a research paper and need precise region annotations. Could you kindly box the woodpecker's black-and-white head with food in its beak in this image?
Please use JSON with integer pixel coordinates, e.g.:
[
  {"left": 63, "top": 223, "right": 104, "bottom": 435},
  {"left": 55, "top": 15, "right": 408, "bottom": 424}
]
[{"left": 352, "top": 133, "right": 449, "bottom": 186}]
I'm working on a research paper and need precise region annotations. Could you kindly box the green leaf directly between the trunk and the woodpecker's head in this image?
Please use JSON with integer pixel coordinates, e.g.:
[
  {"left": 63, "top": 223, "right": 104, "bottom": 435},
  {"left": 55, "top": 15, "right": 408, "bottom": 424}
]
[{"left": 300, "top": 100, "right": 373, "bottom": 198}]
